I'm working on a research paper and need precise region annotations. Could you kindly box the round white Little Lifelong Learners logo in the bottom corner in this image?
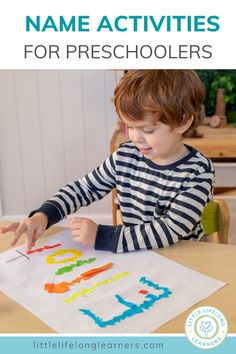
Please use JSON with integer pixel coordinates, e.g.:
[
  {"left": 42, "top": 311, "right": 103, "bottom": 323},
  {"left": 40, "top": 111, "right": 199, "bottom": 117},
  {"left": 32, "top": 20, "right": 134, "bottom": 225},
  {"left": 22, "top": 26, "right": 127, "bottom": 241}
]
[{"left": 185, "top": 306, "right": 228, "bottom": 349}]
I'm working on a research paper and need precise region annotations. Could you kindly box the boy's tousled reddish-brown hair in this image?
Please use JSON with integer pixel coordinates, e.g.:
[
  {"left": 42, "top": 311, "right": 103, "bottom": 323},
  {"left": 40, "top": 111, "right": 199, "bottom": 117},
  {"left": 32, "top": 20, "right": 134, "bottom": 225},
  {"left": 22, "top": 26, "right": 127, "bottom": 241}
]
[{"left": 114, "top": 70, "right": 205, "bottom": 135}]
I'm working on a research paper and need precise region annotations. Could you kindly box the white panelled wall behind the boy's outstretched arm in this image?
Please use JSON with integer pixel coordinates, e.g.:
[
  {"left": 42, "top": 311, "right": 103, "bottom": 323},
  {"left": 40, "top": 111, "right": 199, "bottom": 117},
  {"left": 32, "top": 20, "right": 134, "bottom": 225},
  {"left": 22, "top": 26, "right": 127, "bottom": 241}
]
[{"left": 0, "top": 70, "right": 121, "bottom": 223}]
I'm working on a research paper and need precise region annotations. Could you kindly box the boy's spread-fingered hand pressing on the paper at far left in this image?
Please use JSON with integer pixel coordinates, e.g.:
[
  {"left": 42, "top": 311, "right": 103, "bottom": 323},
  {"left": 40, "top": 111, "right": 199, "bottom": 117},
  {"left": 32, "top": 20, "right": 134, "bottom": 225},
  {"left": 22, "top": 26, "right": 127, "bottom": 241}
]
[{"left": 0, "top": 213, "right": 48, "bottom": 251}]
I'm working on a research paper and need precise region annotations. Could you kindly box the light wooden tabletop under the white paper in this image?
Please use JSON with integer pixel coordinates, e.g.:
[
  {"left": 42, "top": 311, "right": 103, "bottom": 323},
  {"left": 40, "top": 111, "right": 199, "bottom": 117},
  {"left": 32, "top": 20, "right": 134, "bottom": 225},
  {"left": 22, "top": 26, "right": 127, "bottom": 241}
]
[{"left": 0, "top": 222, "right": 236, "bottom": 333}]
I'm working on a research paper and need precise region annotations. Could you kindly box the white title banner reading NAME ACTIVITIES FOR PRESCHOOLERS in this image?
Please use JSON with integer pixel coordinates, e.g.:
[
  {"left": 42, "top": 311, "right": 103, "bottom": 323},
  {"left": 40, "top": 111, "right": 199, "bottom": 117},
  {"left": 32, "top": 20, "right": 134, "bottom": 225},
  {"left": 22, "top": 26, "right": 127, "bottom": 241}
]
[{"left": 0, "top": 0, "right": 236, "bottom": 69}]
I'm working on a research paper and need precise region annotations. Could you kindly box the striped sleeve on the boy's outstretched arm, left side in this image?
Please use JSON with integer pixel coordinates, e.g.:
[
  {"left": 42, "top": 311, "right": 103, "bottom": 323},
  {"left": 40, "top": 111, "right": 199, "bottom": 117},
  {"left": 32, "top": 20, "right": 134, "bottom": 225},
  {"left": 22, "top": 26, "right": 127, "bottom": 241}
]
[{"left": 30, "top": 153, "right": 116, "bottom": 228}]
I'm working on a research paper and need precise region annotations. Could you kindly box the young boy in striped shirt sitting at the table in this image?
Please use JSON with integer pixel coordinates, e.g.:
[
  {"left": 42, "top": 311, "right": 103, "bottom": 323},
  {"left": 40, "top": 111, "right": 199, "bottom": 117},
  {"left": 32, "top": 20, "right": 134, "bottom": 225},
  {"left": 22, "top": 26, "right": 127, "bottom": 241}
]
[{"left": 1, "top": 70, "right": 214, "bottom": 252}]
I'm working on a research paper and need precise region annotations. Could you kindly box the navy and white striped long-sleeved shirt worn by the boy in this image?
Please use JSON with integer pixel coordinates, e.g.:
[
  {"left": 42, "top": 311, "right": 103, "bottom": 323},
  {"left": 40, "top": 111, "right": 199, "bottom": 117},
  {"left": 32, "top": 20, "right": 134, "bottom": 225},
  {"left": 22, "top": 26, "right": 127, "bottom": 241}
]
[{"left": 34, "top": 142, "right": 214, "bottom": 252}]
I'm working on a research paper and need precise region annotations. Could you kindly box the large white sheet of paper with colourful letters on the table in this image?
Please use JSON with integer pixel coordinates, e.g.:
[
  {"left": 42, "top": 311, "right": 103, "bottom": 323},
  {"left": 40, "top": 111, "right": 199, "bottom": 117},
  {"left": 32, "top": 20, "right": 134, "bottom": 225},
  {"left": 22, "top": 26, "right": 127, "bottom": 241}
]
[{"left": 0, "top": 230, "right": 225, "bottom": 333}]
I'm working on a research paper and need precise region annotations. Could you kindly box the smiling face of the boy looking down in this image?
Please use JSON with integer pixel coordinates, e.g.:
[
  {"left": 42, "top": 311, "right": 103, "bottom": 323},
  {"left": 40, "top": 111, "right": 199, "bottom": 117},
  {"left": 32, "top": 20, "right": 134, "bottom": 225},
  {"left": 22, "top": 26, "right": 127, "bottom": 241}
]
[{"left": 122, "top": 116, "right": 183, "bottom": 164}]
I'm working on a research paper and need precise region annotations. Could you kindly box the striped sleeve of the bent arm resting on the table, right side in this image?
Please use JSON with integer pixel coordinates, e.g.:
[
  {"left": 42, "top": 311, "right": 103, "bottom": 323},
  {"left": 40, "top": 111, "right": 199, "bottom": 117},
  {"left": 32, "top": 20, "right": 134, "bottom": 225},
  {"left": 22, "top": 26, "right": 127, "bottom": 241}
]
[{"left": 95, "top": 167, "right": 214, "bottom": 253}]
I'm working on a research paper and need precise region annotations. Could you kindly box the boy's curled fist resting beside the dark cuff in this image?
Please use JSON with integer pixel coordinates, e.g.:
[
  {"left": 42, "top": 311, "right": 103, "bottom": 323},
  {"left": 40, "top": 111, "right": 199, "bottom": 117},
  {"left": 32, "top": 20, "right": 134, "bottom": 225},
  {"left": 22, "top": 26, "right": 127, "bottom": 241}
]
[{"left": 70, "top": 217, "right": 98, "bottom": 247}]
